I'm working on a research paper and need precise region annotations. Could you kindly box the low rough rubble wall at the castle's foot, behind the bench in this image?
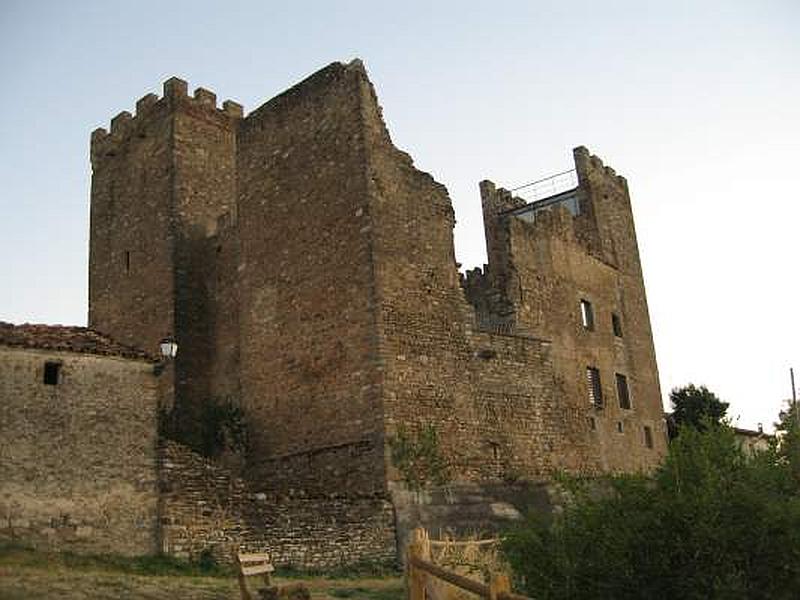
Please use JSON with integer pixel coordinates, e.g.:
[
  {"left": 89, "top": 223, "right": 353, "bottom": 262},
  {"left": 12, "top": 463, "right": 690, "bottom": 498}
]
[{"left": 161, "top": 442, "right": 396, "bottom": 569}]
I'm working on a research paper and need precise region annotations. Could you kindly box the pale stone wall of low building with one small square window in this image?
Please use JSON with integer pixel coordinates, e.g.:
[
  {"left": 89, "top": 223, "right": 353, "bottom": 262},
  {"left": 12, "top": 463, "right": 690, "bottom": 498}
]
[{"left": 0, "top": 347, "right": 158, "bottom": 555}]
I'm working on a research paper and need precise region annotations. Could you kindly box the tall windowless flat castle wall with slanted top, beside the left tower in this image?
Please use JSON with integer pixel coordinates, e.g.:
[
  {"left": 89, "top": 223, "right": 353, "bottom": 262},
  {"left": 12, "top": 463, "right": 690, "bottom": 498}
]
[{"left": 237, "top": 63, "right": 384, "bottom": 493}]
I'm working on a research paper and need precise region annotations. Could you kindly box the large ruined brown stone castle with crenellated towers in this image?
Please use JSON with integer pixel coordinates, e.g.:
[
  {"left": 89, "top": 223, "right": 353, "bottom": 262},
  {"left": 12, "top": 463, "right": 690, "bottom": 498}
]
[{"left": 0, "top": 60, "right": 666, "bottom": 565}]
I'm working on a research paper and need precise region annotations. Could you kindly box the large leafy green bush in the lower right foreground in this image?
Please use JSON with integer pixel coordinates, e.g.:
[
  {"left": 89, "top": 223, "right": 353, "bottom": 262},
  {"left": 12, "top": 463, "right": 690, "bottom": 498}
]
[{"left": 503, "top": 425, "right": 800, "bottom": 600}]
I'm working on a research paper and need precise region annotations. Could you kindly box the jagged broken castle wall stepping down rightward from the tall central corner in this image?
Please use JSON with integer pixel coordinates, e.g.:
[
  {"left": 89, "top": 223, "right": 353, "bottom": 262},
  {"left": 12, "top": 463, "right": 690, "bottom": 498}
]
[{"left": 354, "top": 62, "right": 569, "bottom": 488}]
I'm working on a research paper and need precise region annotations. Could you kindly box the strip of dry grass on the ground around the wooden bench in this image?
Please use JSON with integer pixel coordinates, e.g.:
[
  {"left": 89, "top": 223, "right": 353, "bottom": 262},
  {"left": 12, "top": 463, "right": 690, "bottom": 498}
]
[{"left": 0, "top": 545, "right": 404, "bottom": 600}]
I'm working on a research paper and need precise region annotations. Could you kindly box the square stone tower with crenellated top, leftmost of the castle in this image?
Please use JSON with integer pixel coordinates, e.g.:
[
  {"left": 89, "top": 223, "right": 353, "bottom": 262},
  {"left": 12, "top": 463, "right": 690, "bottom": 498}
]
[{"left": 89, "top": 78, "right": 242, "bottom": 440}]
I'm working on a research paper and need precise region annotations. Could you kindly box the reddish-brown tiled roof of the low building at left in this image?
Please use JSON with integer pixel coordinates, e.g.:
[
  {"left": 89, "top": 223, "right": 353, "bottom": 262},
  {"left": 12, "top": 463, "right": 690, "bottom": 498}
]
[{"left": 0, "top": 321, "right": 153, "bottom": 360}]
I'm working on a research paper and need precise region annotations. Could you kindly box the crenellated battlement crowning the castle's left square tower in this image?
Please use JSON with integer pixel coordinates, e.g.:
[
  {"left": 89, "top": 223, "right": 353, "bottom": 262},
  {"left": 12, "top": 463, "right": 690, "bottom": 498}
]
[{"left": 91, "top": 77, "right": 244, "bottom": 163}]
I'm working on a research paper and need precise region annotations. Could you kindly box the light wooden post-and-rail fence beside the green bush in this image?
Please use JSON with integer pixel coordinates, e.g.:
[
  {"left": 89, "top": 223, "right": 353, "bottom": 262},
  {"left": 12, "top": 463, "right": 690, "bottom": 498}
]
[{"left": 406, "top": 527, "right": 531, "bottom": 600}]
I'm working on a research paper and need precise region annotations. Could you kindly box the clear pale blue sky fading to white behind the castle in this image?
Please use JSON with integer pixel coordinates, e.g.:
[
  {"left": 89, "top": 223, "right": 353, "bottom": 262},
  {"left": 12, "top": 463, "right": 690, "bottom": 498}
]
[{"left": 0, "top": 0, "right": 800, "bottom": 427}]
